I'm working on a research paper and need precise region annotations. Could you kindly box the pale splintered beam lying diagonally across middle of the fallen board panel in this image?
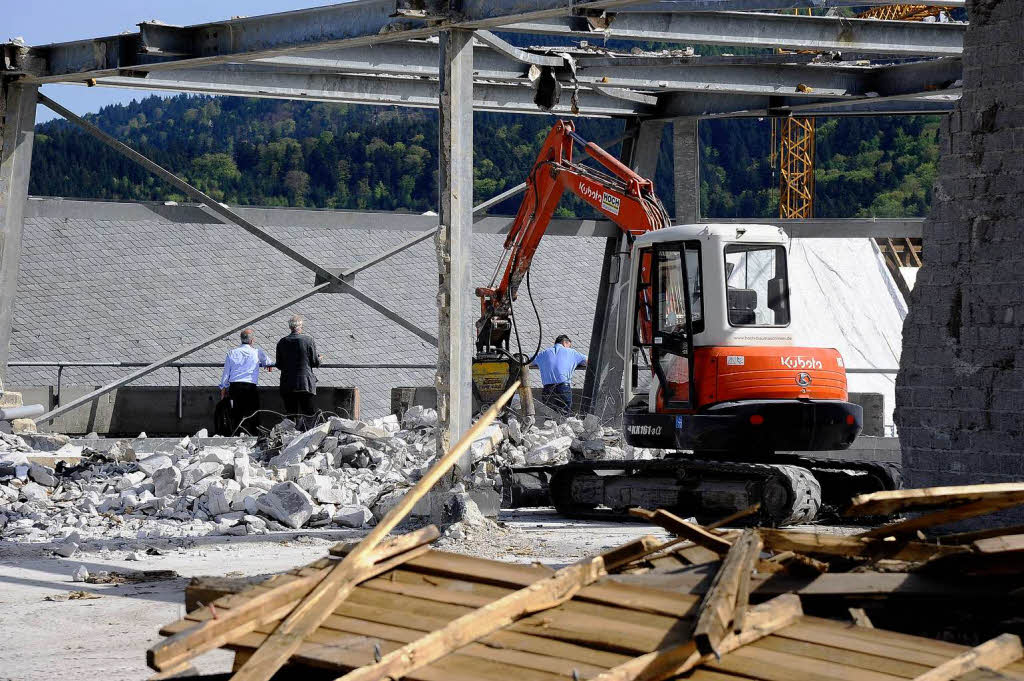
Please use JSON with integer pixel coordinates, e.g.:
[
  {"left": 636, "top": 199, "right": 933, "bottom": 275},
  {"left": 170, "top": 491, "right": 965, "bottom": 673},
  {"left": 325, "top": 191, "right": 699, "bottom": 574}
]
[{"left": 339, "top": 556, "right": 606, "bottom": 681}]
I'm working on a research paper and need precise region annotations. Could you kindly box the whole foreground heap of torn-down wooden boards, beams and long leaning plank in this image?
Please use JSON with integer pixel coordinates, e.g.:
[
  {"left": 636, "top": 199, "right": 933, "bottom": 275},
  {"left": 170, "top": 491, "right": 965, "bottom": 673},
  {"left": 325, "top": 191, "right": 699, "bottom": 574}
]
[{"left": 147, "top": 413, "right": 1024, "bottom": 681}]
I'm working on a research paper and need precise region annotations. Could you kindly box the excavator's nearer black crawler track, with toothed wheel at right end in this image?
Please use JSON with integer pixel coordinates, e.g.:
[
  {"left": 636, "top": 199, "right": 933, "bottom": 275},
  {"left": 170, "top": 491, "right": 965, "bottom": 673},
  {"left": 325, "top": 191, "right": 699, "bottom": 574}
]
[{"left": 536, "top": 459, "right": 821, "bottom": 526}]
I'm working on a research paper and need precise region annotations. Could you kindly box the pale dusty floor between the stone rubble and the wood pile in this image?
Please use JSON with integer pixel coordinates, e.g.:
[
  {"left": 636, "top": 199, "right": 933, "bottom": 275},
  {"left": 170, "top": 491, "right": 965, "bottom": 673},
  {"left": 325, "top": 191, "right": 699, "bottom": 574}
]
[{"left": 0, "top": 510, "right": 667, "bottom": 681}]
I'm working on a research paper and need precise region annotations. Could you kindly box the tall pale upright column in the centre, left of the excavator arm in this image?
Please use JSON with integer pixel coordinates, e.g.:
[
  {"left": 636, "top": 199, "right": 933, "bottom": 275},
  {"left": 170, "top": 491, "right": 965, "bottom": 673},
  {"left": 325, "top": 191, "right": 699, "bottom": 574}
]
[{"left": 435, "top": 30, "right": 475, "bottom": 462}]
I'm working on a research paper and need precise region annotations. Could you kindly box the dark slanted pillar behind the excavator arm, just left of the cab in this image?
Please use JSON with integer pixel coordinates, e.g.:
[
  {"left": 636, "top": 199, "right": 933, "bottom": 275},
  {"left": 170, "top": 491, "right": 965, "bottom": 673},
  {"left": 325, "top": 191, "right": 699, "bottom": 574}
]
[{"left": 584, "top": 121, "right": 665, "bottom": 427}]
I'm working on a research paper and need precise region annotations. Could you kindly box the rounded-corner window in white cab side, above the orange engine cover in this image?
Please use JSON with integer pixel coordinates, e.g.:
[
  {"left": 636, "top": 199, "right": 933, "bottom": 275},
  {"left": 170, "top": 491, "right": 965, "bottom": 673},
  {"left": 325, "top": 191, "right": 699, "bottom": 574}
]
[{"left": 725, "top": 244, "right": 790, "bottom": 327}]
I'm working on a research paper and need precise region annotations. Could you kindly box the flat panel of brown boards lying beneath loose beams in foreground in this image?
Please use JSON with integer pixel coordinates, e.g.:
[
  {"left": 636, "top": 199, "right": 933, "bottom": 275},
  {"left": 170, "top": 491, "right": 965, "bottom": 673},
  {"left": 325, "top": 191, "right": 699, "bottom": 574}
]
[{"left": 150, "top": 534, "right": 1024, "bottom": 681}]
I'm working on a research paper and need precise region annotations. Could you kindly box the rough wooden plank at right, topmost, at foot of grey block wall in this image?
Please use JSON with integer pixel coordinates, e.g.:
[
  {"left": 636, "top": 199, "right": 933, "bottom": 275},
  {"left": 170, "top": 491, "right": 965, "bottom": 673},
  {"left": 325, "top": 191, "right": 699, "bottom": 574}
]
[{"left": 844, "top": 482, "right": 1024, "bottom": 517}]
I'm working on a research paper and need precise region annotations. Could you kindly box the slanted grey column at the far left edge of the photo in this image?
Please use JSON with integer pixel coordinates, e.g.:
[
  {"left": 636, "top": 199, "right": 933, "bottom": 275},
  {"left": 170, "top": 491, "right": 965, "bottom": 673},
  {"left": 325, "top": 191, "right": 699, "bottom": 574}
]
[{"left": 0, "top": 84, "right": 39, "bottom": 382}]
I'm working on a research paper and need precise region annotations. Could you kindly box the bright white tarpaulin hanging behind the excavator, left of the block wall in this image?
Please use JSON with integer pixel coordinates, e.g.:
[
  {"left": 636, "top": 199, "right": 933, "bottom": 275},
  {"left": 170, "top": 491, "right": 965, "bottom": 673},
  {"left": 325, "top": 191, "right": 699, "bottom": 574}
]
[{"left": 790, "top": 239, "right": 906, "bottom": 434}]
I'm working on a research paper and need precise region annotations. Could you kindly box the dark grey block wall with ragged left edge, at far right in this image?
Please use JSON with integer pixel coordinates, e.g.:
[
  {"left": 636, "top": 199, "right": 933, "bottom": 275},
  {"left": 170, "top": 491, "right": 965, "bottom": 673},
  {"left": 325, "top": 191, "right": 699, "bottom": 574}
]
[{"left": 896, "top": 0, "right": 1024, "bottom": 524}]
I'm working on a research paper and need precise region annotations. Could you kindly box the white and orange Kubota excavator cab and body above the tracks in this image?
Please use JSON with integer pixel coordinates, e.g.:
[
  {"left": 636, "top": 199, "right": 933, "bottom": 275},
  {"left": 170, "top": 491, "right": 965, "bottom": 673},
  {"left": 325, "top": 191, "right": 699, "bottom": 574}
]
[{"left": 624, "top": 224, "right": 862, "bottom": 456}]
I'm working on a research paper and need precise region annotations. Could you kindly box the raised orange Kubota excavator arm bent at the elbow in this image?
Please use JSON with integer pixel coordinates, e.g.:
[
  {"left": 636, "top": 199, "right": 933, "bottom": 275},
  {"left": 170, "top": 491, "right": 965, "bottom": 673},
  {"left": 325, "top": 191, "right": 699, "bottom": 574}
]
[{"left": 476, "top": 121, "right": 670, "bottom": 354}]
